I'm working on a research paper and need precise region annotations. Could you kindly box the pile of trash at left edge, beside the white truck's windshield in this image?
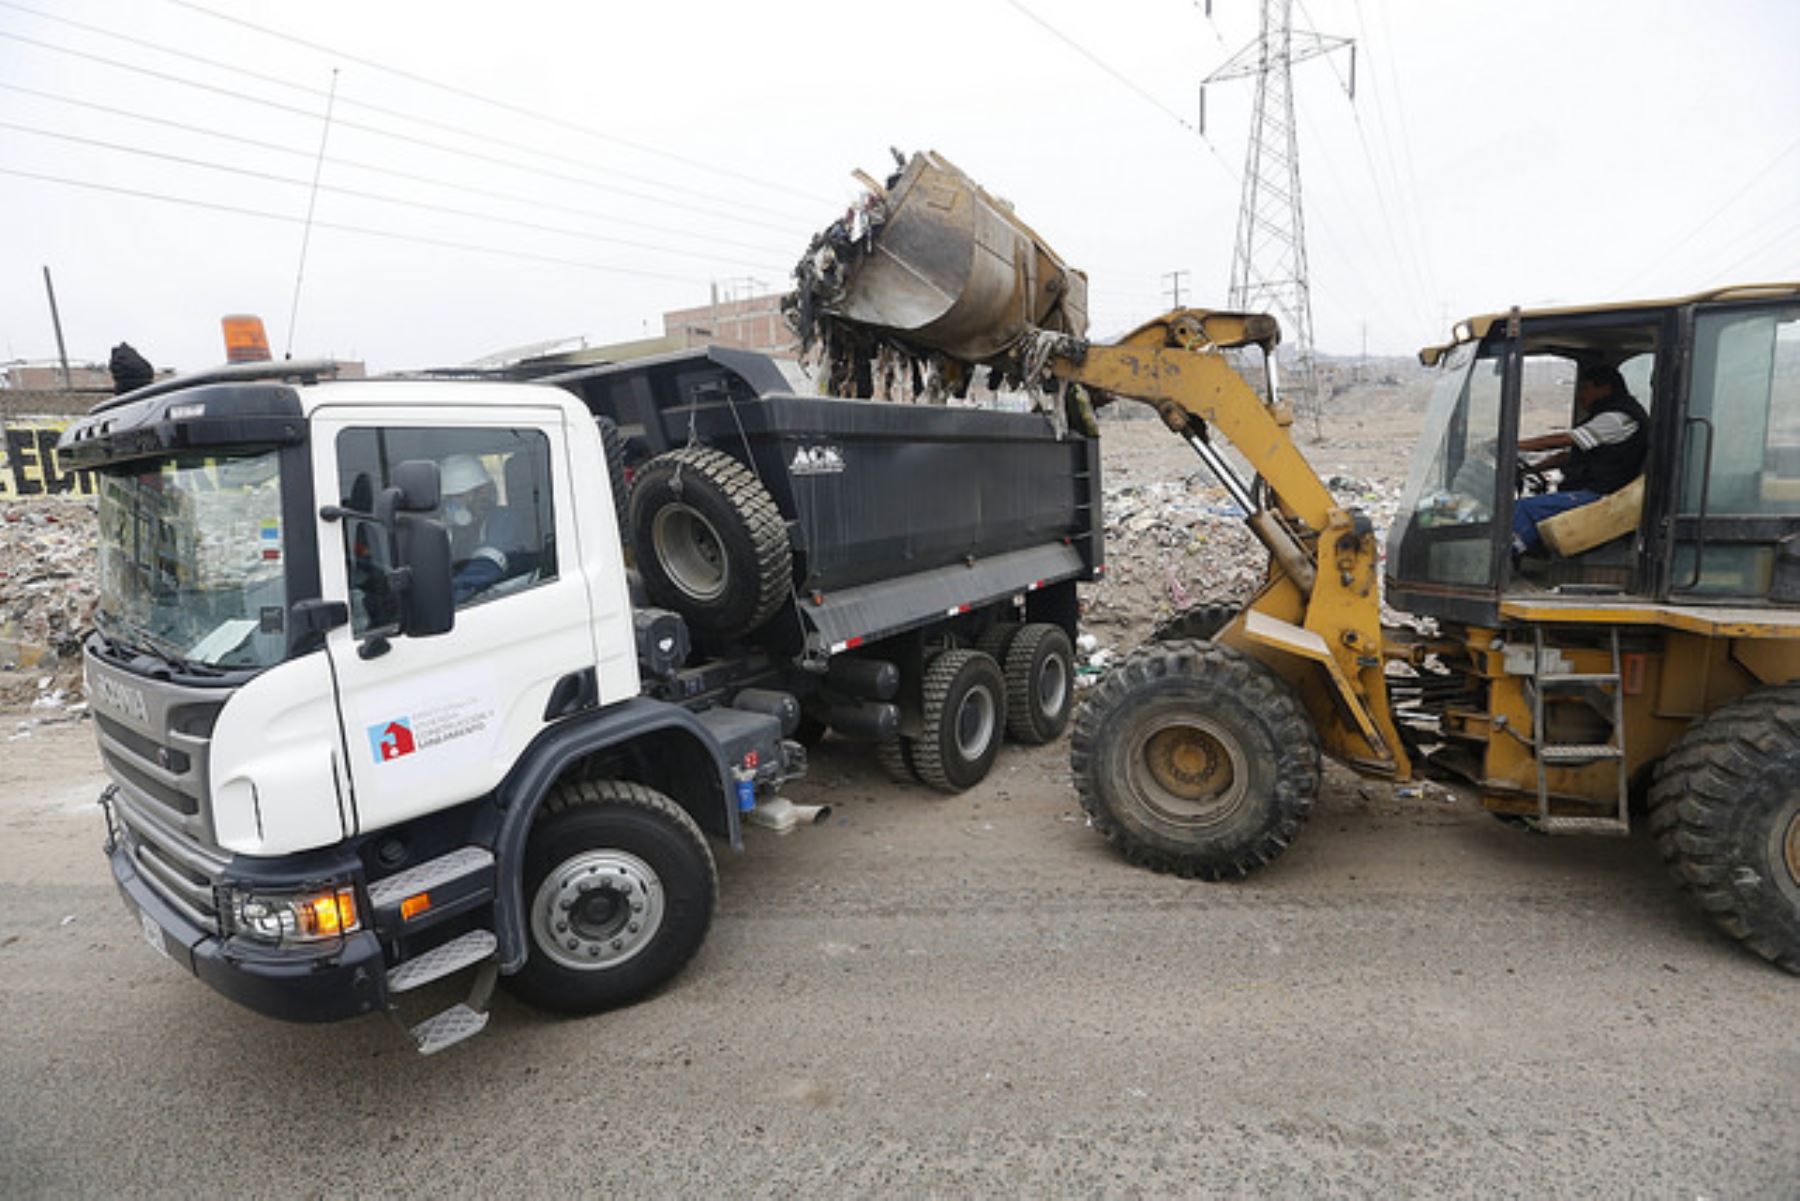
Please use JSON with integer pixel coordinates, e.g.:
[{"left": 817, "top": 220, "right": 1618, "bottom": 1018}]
[{"left": 0, "top": 499, "right": 99, "bottom": 704}]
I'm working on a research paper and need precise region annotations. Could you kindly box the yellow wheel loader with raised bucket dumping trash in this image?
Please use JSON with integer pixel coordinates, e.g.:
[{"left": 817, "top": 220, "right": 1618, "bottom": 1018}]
[{"left": 794, "top": 145, "right": 1800, "bottom": 972}]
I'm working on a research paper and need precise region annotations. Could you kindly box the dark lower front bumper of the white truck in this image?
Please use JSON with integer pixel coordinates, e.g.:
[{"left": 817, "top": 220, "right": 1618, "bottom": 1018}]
[{"left": 106, "top": 839, "right": 387, "bottom": 1023}]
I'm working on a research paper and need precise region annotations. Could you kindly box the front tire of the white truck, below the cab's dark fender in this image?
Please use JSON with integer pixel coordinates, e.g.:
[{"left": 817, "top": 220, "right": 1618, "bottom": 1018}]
[{"left": 508, "top": 780, "right": 718, "bottom": 1014}]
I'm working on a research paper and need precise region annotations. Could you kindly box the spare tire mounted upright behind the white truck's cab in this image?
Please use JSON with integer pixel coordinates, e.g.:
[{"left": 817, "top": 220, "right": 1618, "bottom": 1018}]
[{"left": 630, "top": 447, "right": 794, "bottom": 637}]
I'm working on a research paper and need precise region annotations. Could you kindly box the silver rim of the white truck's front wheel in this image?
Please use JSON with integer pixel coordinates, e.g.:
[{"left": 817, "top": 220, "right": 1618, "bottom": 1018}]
[{"left": 531, "top": 850, "right": 664, "bottom": 971}]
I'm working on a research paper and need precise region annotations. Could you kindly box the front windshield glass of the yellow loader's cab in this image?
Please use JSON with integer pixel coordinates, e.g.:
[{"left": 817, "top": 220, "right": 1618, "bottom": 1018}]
[{"left": 1388, "top": 346, "right": 1512, "bottom": 587}]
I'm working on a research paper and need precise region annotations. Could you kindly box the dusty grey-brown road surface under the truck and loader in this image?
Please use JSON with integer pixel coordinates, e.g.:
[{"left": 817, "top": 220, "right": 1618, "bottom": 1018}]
[{"left": 0, "top": 727, "right": 1800, "bottom": 1197}]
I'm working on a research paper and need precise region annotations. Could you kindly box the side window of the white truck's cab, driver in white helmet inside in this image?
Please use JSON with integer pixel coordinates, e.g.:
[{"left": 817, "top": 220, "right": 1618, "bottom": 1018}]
[{"left": 338, "top": 427, "right": 556, "bottom": 637}]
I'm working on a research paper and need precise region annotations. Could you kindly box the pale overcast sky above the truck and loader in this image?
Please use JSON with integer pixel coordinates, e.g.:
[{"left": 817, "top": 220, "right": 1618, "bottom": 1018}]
[{"left": 0, "top": 0, "right": 1800, "bottom": 369}]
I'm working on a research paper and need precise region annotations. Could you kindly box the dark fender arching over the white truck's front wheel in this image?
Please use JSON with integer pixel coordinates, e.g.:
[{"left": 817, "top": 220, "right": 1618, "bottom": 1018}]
[{"left": 493, "top": 697, "right": 742, "bottom": 974}]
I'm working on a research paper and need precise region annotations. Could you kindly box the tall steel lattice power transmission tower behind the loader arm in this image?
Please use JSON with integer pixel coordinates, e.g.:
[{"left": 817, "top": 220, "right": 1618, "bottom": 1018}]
[{"left": 1201, "top": 0, "right": 1355, "bottom": 436}]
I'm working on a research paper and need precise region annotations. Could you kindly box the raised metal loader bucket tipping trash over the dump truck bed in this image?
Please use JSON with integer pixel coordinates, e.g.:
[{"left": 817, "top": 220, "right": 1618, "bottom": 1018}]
[{"left": 819, "top": 151, "right": 1087, "bottom": 362}]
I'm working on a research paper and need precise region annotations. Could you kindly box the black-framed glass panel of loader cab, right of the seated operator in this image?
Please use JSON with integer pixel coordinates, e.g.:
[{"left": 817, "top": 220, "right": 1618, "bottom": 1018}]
[{"left": 1660, "top": 301, "right": 1800, "bottom": 603}]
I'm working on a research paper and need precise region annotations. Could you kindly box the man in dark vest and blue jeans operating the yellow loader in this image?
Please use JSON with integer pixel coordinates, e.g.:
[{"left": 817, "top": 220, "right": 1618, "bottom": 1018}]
[{"left": 1512, "top": 364, "right": 1651, "bottom": 556}]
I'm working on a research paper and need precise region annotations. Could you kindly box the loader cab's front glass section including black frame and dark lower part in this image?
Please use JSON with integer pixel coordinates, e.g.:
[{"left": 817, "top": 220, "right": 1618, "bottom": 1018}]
[{"left": 1388, "top": 340, "right": 1517, "bottom": 621}]
